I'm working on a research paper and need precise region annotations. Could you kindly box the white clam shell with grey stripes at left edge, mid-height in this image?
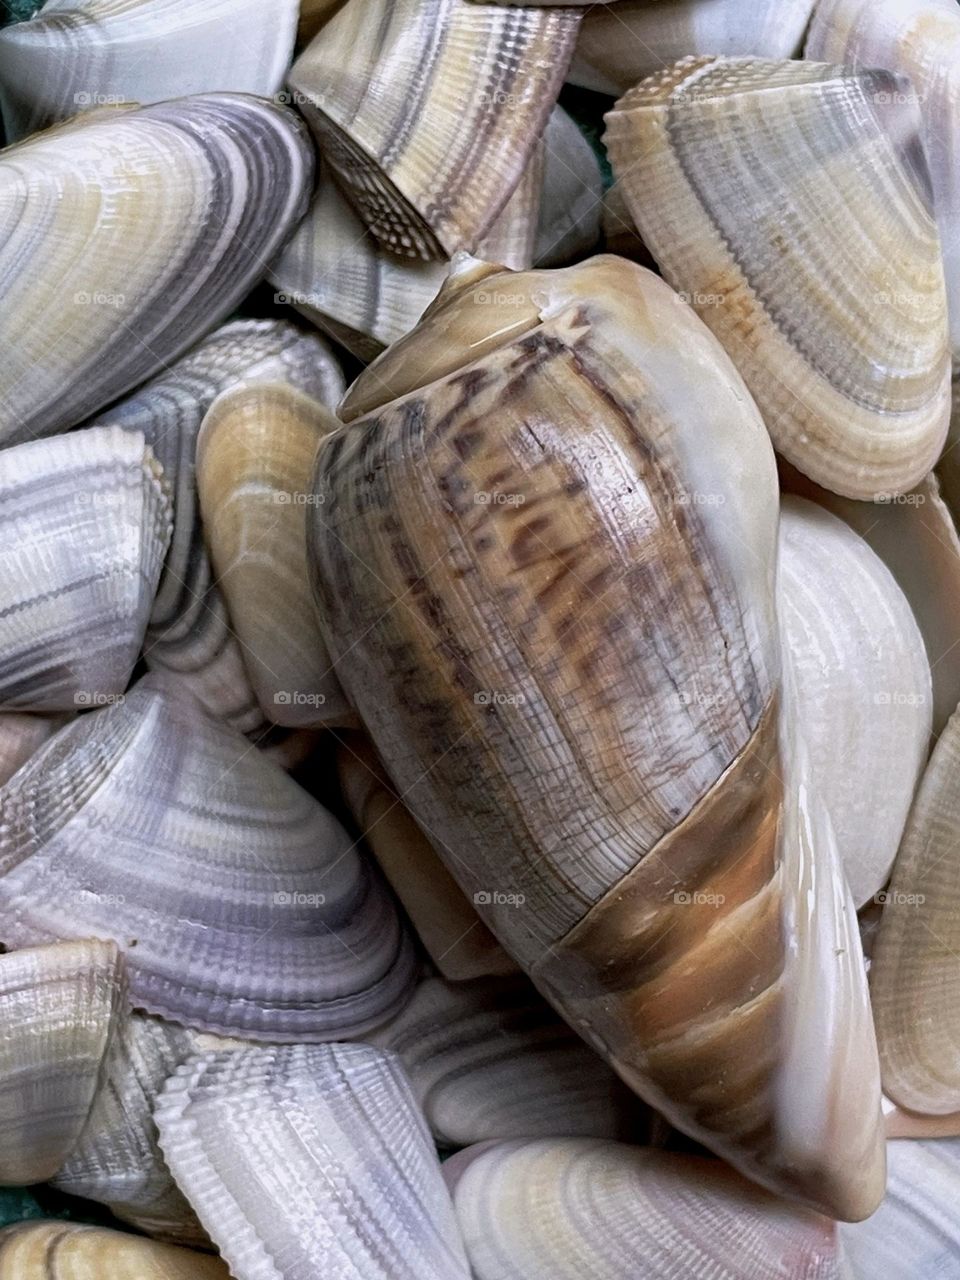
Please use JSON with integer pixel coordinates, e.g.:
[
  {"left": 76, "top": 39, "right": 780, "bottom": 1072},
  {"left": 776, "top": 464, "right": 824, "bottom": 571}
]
[{"left": 0, "top": 428, "right": 170, "bottom": 712}]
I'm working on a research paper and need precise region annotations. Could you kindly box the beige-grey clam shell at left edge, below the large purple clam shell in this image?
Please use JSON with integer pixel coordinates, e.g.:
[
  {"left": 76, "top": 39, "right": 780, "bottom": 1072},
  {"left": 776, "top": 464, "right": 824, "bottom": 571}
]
[{"left": 0, "top": 941, "right": 124, "bottom": 1182}]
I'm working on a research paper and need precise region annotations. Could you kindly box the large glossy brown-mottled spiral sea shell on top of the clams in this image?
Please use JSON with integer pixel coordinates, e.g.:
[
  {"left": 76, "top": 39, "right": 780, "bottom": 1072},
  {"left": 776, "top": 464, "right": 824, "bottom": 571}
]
[{"left": 310, "top": 257, "right": 883, "bottom": 1217}]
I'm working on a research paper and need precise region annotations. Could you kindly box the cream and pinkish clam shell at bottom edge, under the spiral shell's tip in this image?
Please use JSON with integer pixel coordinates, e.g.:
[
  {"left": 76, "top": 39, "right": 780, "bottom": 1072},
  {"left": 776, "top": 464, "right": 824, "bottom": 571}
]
[{"left": 444, "top": 1138, "right": 841, "bottom": 1280}]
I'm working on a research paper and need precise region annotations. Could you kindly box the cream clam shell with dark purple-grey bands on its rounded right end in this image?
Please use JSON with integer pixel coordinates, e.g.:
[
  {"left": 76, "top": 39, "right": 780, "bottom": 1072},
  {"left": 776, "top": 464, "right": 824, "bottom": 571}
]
[{"left": 0, "top": 93, "right": 314, "bottom": 442}]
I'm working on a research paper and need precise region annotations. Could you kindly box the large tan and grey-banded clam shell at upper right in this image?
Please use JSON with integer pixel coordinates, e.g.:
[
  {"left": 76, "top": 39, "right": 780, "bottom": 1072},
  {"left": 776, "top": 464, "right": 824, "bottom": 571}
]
[{"left": 607, "top": 58, "right": 950, "bottom": 500}]
